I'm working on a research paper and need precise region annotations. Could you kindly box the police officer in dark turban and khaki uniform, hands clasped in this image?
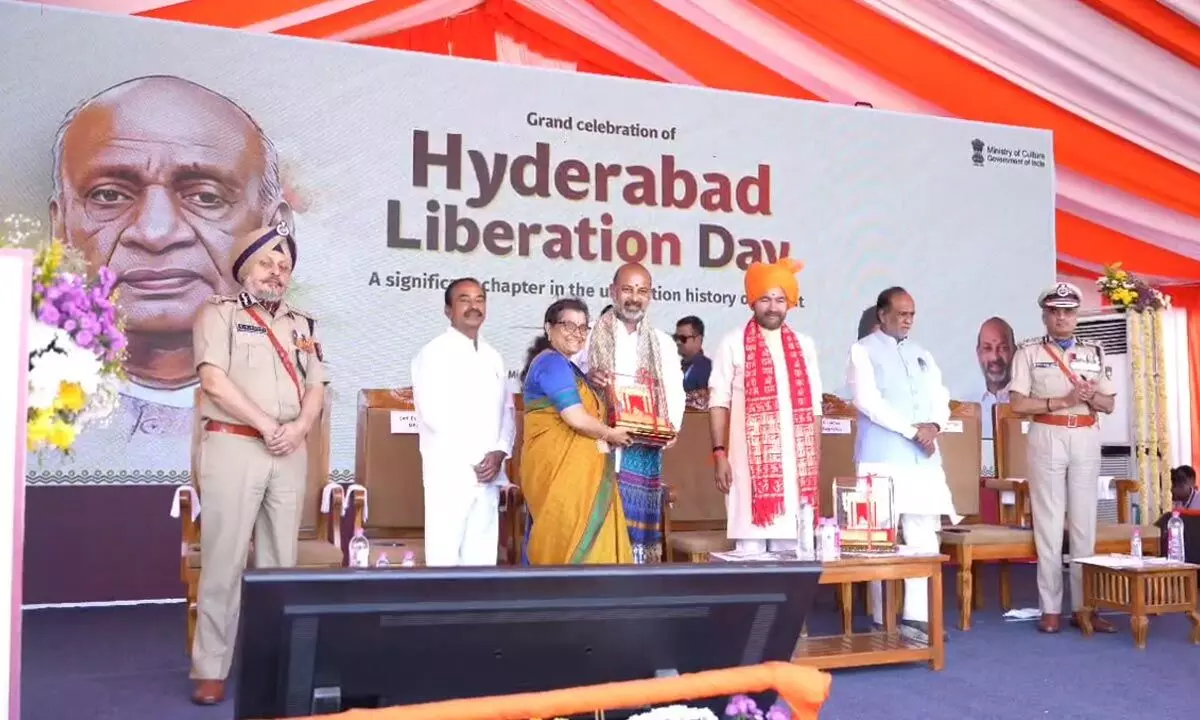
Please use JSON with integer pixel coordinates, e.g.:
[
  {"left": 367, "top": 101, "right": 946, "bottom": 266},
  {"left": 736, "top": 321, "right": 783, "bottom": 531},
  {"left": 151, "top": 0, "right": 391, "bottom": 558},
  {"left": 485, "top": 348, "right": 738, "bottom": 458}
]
[{"left": 191, "top": 223, "right": 326, "bottom": 704}]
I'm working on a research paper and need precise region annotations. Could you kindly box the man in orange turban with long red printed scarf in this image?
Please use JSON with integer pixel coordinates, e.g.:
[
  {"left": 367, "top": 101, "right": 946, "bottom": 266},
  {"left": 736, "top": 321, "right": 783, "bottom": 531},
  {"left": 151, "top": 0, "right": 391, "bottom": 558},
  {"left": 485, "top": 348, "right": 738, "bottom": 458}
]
[{"left": 708, "top": 258, "right": 821, "bottom": 553}]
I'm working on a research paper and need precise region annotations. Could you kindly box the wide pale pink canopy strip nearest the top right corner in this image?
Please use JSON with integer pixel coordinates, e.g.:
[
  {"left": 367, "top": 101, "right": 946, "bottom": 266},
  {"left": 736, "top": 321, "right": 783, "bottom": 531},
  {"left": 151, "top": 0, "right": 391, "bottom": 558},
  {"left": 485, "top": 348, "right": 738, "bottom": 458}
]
[{"left": 858, "top": 0, "right": 1200, "bottom": 172}]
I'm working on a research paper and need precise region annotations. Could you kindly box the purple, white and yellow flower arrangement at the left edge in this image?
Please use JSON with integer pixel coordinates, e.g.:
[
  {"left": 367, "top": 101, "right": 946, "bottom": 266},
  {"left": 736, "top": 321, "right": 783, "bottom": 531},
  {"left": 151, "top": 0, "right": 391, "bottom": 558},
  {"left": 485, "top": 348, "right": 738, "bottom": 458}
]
[{"left": 0, "top": 215, "right": 126, "bottom": 454}]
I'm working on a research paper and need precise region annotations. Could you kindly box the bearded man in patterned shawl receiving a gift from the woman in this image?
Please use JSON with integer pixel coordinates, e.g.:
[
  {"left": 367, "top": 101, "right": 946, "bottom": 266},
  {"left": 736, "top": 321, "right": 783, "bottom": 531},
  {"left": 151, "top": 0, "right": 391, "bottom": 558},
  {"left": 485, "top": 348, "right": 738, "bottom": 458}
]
[{"left": 583, "top": 263, "right": 686, "bottom": 563}]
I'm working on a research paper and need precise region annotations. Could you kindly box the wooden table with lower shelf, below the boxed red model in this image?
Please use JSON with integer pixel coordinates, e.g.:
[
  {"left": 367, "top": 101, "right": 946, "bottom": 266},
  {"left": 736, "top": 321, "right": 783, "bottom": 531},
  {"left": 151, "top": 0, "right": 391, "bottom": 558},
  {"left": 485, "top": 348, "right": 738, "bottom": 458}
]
[{"left": 792, "top": 554, "right": 949, "bottom": 670}]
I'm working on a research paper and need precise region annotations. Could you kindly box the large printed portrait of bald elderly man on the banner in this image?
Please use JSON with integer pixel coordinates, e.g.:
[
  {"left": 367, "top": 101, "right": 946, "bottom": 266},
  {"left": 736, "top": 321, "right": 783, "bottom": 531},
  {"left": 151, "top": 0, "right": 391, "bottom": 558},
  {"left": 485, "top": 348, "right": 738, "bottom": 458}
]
[{"left": 42, "top": 76, "right": 294, "bottom": 470}]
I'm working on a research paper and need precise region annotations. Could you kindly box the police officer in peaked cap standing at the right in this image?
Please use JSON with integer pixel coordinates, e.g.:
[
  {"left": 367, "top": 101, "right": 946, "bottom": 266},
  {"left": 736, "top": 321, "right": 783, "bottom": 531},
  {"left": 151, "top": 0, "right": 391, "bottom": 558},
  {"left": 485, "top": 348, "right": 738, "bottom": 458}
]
[{"left": 1008, "top": 282, "right": 1116, "bottom": 632}]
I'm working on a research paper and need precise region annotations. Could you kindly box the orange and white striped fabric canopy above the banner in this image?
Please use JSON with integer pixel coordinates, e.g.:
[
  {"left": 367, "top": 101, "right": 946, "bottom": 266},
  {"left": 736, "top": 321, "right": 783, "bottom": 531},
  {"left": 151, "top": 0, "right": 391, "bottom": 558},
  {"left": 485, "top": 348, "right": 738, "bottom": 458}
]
[{"left": 35, "top": 0, "right": 1200, "bottom": 284}]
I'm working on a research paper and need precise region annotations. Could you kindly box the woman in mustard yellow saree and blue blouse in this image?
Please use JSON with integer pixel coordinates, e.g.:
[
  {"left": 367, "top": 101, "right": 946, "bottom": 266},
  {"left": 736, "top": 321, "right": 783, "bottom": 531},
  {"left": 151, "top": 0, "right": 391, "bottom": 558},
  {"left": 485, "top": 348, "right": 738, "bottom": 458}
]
[{"left": 521, "top": 299, "right": 634, "bottom": 565}]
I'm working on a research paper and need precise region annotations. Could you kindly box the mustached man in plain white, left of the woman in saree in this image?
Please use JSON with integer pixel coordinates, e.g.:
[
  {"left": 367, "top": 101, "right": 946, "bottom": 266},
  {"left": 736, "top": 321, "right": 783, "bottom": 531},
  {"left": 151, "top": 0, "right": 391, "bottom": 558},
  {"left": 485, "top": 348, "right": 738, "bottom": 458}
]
[{"left": 412, "top": 278, "right": 516, "bottom": 566}]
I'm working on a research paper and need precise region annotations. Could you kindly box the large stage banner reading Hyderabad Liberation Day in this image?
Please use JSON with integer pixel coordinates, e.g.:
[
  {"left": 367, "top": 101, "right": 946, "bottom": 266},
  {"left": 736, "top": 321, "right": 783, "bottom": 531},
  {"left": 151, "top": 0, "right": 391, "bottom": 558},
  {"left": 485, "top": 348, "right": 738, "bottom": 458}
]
[{"left": 0, "top": 4, "right": 1055, "bottom": 484}]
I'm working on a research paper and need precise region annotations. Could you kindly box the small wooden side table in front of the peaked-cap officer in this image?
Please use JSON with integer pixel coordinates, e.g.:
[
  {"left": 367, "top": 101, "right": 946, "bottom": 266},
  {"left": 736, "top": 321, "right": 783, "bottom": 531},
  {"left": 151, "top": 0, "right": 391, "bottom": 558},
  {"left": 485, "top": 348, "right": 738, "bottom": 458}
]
[{"left": 1074, "top": 558, "right": 1200, "bottom": 649}]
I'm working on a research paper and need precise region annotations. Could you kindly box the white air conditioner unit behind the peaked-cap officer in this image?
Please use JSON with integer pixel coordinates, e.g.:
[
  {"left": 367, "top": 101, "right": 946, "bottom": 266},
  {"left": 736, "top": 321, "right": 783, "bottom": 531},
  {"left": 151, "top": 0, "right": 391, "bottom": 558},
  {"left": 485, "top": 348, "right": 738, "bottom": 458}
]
[{"left": 1075, "top": 313, "right": 1136, "bottom": 487}]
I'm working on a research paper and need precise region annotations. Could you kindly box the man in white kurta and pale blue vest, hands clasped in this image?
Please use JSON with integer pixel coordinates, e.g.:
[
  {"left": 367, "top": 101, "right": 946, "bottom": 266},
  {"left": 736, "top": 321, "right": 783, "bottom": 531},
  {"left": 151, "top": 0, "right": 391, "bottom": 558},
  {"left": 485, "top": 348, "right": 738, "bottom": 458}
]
[{"left": 846, "top": 288, "right": 961, "bottom": 632}]
